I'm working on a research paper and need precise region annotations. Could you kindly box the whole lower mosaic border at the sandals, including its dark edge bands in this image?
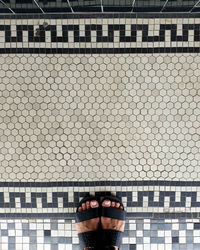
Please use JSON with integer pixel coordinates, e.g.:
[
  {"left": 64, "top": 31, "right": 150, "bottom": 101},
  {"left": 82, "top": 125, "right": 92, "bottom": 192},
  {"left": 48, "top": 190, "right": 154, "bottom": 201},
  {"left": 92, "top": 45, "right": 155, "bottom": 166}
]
[{"left": 0, "top": 181, "right": 200, "bottom": 218}]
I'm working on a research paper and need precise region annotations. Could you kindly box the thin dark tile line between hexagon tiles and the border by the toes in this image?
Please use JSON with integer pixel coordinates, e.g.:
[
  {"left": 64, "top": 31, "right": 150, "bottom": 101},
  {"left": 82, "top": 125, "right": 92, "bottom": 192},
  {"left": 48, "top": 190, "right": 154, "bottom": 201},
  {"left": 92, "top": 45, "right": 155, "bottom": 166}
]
[{"left": 0, "top": 180, "right": 200, "bottom": 187}]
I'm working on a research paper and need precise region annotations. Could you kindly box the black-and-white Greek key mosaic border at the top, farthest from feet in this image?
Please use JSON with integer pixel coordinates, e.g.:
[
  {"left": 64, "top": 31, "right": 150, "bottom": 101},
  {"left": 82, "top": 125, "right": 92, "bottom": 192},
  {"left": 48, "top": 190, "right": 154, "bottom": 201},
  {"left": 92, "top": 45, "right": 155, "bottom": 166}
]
[{"left": 0, "top": 15, "right": 200, "bottom": 54}]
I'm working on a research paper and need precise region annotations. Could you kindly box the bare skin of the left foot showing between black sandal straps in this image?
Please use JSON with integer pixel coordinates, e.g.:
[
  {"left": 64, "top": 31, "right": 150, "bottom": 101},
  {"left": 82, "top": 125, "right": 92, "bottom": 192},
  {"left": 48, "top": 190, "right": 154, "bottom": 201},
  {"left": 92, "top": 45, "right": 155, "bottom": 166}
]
[{"left": 75, "top": 200, "right": 100, "bottom": 250}]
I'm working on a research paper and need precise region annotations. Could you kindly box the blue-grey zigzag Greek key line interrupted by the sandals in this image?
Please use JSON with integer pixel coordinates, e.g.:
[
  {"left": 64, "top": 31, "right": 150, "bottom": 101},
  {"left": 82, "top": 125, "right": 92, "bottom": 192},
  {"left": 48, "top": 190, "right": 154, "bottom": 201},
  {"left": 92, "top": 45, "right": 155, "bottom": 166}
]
[{"left": 0, "top": 191, "right": 200, "bottom": 208}]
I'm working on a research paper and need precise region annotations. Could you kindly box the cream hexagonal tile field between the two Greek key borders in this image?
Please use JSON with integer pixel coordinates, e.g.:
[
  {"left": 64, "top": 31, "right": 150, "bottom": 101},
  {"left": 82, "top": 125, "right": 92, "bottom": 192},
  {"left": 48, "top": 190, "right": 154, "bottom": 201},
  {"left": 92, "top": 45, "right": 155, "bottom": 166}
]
[{"left": 0, "top": 49, "right": 200, "bottom": 216}]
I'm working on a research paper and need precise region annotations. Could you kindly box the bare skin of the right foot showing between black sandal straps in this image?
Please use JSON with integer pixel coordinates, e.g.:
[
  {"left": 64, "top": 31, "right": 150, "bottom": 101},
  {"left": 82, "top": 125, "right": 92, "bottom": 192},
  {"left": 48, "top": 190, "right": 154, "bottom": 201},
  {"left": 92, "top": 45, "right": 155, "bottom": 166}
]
[{"left": 101, "top": 199, "right": 125, "bottom": 250}]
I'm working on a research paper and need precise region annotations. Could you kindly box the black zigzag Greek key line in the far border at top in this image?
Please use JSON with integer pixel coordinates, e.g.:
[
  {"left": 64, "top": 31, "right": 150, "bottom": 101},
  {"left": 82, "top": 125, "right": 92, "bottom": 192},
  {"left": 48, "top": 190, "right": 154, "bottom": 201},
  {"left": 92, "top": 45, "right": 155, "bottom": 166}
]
[{"left": 0, "top": 24, "right": 200, "bottom": 43}]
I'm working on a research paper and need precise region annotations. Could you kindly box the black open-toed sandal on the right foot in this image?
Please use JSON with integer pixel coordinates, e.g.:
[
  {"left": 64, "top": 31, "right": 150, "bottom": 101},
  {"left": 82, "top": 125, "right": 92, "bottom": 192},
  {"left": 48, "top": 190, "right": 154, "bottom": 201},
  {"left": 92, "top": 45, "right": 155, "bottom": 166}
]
[{"left": 101, "top": 195, "right": 126, "bottom": 248}]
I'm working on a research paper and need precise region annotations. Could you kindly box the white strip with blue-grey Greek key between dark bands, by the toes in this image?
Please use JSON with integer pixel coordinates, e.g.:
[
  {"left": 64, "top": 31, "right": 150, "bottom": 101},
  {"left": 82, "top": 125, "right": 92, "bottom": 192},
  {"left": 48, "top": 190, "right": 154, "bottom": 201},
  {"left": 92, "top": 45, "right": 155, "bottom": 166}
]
[{"left": 0, "top": 185, "right": 200, "bottom": 217}]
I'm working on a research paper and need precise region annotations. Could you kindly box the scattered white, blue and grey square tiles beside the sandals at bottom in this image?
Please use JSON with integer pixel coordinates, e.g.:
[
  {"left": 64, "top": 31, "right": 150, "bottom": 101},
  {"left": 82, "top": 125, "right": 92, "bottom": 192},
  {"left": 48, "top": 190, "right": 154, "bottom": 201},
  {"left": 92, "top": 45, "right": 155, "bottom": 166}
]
[{"left": 0, "top": 219, "right": 200, "bottom": 250}]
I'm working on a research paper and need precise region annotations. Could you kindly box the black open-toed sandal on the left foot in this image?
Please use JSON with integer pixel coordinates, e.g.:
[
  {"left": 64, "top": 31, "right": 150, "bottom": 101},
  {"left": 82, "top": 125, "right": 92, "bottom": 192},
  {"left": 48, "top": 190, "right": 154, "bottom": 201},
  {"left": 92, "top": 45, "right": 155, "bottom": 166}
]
[{"left": 75, "top": 196, "right": 100, "bottom": 249}]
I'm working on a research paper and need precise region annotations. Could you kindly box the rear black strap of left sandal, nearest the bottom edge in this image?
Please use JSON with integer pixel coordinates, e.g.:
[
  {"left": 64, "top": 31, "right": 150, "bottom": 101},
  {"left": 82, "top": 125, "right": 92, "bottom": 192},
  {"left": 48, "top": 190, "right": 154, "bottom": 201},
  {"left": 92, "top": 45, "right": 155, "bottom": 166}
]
[{"left": 78, "top": 231, "right": 98, "bottom": 249}]
